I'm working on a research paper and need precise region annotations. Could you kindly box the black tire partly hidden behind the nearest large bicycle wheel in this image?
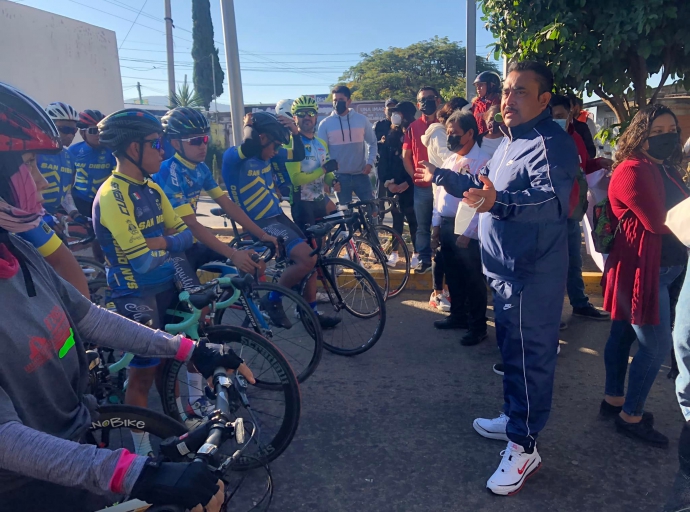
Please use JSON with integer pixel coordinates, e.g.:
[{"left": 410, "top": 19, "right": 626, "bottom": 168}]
[{"left": 214, "top": 282, "right": 323, "bottom": 383}]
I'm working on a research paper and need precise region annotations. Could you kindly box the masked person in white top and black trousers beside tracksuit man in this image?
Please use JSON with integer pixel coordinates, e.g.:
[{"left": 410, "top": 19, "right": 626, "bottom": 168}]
[{"left": 431, "top": 110, "right": 489, "bottom": 346}]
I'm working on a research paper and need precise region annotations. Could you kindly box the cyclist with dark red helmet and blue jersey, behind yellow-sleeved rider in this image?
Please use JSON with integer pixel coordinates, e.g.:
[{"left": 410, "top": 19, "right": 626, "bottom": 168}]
[{"left": 68, "top": 110, "right": 116, "bottom": 217}]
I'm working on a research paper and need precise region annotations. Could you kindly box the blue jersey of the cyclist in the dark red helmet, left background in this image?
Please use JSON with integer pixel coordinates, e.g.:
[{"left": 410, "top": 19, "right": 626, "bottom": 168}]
[{"left": 67, "top": 142, "right": 117, "bottom": 201}]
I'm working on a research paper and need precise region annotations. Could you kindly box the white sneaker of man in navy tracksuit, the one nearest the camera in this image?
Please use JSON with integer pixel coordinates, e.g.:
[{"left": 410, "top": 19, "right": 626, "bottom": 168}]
[{"left": 486, "top": 442, "right": 541, "bottom": 496}]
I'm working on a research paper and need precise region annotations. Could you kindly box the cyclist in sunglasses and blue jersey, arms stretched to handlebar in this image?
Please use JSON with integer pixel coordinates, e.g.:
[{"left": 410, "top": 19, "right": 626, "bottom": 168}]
[{"left": 152, "top": 107, "right": 276, "bottom": 272}]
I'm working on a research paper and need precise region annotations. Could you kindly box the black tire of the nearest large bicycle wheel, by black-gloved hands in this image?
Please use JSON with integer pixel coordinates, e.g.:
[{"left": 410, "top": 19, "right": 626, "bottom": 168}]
[{"left": 162, "top": 325, "right": 302, "bottom": 470}]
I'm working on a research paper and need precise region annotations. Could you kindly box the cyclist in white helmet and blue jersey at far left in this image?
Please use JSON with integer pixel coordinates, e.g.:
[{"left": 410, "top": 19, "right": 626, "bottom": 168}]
[{"left": 36, "top": 102, "right": 88, "bottom": 228}]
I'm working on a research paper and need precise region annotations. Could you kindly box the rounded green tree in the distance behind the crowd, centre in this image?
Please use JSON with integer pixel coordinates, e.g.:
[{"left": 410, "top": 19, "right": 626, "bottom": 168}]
[{"left": 340, "top": 36, "right": 496, "bottom": 101}]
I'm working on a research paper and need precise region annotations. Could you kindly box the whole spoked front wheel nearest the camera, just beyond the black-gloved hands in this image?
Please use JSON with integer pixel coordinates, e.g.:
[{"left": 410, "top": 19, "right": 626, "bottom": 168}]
[{"left": 162, "top": 325, "right": 302, "bottom": 470}]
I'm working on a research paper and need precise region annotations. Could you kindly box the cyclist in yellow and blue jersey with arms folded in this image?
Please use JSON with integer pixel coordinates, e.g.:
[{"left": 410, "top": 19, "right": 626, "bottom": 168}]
[{"left": 93, "top": 108, "right": 198, "bottom": 454}]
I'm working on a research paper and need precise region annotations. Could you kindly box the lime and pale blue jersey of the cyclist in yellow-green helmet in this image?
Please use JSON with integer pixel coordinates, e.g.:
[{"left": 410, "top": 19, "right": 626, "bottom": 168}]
[{"left": 286, "top": 135, "right": 335, "bottom": 201}]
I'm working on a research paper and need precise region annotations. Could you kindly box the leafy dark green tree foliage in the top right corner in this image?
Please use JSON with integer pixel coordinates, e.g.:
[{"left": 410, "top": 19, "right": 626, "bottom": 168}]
[{"left": 480, "top": 0, "right": 690, "bottom": 123}]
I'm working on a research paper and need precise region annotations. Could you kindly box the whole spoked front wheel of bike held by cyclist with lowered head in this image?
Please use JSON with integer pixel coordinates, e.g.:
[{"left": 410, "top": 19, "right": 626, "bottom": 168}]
[{"left": 302, "top": 258, "right": 386, "bottom": 356}]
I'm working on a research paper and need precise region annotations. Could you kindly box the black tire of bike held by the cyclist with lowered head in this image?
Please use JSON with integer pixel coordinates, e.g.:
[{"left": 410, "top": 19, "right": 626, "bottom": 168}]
[{"left": 302, "top": 258, "right": 386, "bottom": 356}]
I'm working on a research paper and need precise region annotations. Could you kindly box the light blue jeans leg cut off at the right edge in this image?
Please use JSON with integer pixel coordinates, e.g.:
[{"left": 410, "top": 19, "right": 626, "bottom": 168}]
[{"left": 673, "top": 256, "right": 690, "bottom": 421}]
